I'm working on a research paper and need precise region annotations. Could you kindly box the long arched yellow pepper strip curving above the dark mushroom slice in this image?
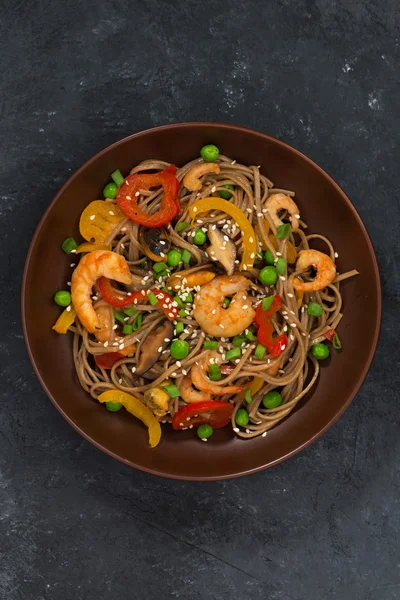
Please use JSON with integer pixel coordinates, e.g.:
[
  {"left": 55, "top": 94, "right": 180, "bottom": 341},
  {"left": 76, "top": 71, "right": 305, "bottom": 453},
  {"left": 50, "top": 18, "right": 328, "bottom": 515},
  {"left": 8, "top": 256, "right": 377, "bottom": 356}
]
[{"left": 189, "top": 196, "right": 257, "bottom": 271}]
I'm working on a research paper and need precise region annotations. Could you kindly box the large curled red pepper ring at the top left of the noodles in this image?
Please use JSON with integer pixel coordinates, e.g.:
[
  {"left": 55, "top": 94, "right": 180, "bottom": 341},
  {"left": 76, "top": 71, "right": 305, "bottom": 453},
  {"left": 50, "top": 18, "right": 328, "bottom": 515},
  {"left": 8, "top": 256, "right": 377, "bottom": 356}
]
[{"left": 117, "top": 165, "right": 181, "bottom": 227}]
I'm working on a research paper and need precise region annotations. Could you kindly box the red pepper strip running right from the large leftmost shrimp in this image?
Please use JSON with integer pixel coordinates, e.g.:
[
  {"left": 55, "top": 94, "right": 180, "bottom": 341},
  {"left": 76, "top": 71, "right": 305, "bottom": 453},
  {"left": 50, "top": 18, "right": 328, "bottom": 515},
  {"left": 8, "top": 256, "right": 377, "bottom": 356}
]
[{"left": 97, "top": 278, "right": 179, "bottom": 321}]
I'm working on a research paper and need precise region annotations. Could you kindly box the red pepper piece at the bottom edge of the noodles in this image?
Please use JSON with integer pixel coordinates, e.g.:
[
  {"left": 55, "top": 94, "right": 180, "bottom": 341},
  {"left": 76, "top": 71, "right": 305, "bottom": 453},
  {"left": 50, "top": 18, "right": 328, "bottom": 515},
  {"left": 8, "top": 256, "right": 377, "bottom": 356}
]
[{"left": 172, "top": 400, "right": 234, "bottom": 431}]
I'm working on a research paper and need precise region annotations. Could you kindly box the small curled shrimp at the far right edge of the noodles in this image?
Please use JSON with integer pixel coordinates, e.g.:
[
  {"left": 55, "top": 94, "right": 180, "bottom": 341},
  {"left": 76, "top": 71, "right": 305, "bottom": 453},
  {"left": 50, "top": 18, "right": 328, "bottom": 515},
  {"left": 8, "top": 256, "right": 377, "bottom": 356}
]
[{"left": 293, "top": 250, "right": 336, "bottom": 292}]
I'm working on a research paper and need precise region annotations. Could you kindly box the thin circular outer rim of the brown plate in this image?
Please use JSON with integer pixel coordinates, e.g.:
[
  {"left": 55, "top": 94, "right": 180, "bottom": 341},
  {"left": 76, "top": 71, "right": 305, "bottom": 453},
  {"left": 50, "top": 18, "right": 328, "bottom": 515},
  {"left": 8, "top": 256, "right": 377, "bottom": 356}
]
[{"left": 21, "top": 121, "right": 382, "bottom": 481}]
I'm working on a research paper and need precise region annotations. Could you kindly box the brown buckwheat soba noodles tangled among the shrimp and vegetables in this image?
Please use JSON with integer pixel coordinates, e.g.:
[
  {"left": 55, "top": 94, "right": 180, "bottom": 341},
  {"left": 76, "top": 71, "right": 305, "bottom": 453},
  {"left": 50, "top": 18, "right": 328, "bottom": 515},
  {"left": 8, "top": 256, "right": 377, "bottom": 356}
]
[{"left": 71, "top": 155, "right": 357, "bottom": 438}]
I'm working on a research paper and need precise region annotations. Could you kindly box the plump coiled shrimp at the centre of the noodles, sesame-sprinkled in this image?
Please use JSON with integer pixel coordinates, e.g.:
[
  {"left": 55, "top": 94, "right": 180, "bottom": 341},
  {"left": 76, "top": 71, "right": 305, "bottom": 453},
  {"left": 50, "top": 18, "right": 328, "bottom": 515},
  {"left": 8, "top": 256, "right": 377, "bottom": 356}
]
[{"left": 193, "top": 274, "right": 255, "bottom": 337}]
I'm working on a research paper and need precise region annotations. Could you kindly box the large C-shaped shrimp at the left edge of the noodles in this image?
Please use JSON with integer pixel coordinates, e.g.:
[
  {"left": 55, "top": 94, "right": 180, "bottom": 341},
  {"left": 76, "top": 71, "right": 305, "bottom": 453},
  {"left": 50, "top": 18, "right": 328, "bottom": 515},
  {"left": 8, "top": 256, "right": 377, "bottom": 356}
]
[{"left": 71, "top": 250, "right": 132, "bottom": 333}]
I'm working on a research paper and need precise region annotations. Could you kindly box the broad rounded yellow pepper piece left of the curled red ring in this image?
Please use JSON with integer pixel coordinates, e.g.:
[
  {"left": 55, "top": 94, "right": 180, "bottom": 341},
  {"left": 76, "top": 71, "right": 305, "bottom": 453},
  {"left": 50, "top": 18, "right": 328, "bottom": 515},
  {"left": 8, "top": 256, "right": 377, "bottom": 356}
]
[{"left": 79, "top": 200, "right": 125, "bottom": 244}]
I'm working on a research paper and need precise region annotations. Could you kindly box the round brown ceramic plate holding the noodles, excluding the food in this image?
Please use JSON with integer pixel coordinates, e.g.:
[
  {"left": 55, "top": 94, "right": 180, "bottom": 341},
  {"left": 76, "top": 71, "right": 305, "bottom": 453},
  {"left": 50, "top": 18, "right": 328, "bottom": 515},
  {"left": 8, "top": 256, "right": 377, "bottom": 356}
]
[{"left": 22, "top": 123, "right": 381, "bottom": 480}]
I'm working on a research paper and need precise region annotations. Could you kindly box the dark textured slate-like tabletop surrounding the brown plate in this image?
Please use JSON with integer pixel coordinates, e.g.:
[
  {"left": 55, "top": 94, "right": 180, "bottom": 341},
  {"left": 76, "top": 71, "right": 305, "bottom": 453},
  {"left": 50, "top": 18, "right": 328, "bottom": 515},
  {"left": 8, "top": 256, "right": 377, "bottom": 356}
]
[{"left": 0, "top": 0, "right": 400, "bottom": 600}]
